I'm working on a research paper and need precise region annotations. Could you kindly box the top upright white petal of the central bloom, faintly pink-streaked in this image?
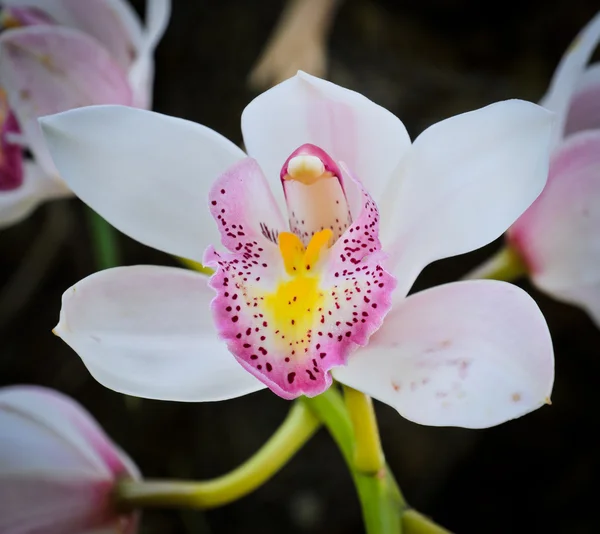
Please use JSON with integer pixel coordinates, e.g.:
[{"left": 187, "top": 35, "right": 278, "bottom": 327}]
[{"left": 242, "top": 71, "right": 410, "bottom": 211}]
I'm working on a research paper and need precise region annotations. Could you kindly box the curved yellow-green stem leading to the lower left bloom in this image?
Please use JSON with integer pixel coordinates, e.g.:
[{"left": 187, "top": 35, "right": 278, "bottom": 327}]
[{"left": 116, "top": 402, "right": 321, "bottom": 510}]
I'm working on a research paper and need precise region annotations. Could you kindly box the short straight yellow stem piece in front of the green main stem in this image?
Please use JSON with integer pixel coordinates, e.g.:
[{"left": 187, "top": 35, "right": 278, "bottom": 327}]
[{"left": 344, "top": 386, "right": 385, "bottom": 475}]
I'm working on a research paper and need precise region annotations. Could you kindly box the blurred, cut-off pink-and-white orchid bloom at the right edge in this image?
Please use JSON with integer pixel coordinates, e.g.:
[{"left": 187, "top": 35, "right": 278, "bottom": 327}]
[{"left": 507, "top": 13, "right": 600, "bottom": 326}]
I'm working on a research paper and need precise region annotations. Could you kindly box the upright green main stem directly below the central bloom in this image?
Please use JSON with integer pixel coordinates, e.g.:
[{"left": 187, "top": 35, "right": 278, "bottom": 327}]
[{"left": 303, "top": 388, "right": 406, "bottom": 534}]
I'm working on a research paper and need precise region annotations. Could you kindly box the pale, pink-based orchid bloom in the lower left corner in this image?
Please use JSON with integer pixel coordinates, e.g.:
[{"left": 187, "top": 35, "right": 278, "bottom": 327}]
[{"left": 0, "top": 386, "right": 139, "bottom": 534}]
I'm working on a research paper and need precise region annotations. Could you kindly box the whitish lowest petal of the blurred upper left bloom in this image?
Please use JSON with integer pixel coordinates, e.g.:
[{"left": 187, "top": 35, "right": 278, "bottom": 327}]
[{"left": 0, "top": 161, "right": 72, "bottom": 228}]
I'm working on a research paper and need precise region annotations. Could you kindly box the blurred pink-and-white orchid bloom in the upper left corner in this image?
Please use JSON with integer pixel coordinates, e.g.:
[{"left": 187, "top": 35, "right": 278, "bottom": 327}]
[{"left": 0, "top": 0, "right": 170, "bottom": 227}]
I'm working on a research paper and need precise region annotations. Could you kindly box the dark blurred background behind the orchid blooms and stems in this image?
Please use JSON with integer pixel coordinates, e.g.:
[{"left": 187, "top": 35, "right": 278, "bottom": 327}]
[{"left": 0, "top": 0, "right": 600, "bottom": 534}]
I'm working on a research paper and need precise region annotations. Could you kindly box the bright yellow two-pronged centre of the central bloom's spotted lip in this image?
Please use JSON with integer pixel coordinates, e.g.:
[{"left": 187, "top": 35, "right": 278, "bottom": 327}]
[{"left": 264, "top": 228, "right": 333, "bottom": 349}]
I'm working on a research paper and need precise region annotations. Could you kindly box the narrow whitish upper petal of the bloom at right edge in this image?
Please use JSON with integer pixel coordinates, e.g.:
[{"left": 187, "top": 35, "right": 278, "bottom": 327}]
[{"left": 540, "top": 13, "right": 600, "bottom": 145}]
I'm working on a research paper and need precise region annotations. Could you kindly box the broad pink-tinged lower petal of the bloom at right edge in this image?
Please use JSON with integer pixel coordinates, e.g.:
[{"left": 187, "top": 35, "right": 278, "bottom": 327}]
[{"left": 508, "top": 130, "right": 600, "bottom": 324}]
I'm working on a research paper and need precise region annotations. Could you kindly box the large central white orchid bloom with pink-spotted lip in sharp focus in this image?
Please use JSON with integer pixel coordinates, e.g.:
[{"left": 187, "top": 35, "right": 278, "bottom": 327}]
[{"left": 41, "top": 72, "right": 553, "bottom": 428}]
